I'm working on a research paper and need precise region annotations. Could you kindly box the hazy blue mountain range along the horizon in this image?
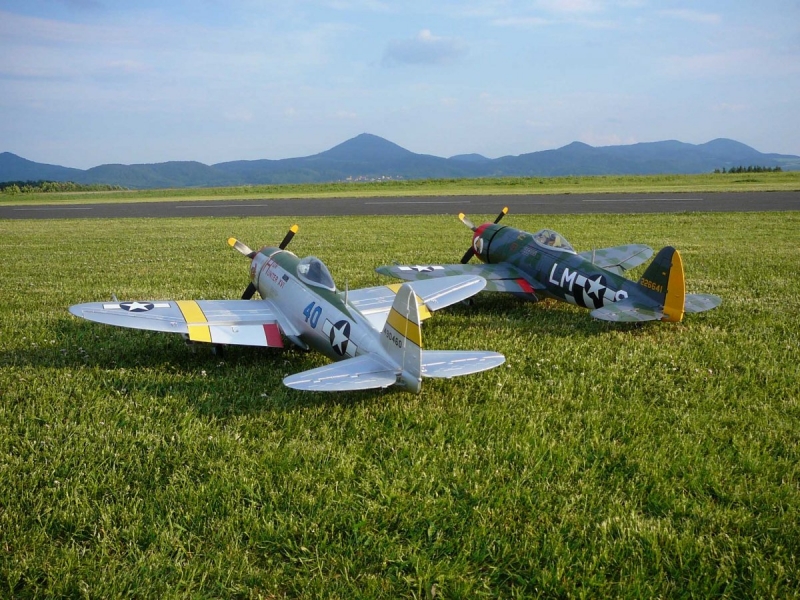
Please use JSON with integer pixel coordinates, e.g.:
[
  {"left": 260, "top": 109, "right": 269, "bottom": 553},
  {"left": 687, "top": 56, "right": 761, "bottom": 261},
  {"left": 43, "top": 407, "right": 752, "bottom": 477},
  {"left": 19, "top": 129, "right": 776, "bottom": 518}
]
[{"left": 0, "top": 133, "right": 800, "bottom": 189}]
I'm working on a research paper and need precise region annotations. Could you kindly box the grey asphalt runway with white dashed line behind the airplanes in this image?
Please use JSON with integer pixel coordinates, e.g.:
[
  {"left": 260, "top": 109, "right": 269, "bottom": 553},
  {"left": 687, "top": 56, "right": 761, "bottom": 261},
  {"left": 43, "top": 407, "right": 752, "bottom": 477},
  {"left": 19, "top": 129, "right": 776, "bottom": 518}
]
[{"left": 0, "top": 192, "right": 800, "bottom": 219}]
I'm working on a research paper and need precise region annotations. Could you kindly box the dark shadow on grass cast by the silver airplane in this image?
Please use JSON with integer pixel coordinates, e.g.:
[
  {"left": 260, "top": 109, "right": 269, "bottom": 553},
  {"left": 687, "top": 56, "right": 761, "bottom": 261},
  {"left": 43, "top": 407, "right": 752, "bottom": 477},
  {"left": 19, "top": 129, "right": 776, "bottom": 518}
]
[{"left": 9, "top": 318, "right": 412, "bottom": 417}]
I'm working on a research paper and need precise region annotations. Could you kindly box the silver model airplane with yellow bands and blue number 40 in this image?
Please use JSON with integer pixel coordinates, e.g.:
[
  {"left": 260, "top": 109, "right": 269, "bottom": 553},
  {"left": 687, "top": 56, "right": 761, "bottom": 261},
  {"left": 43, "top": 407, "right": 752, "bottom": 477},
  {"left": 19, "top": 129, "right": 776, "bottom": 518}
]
[{"left": 69, "top": 225, "right": 505, "bottom": 392}]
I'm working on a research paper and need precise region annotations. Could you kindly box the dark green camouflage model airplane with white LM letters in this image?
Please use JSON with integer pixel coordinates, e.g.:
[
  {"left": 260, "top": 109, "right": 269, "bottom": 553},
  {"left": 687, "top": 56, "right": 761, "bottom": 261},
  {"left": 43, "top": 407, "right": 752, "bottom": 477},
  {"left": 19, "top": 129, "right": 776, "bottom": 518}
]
[{"left": 376, "top": 208, "right": 722, "bottom": 322}]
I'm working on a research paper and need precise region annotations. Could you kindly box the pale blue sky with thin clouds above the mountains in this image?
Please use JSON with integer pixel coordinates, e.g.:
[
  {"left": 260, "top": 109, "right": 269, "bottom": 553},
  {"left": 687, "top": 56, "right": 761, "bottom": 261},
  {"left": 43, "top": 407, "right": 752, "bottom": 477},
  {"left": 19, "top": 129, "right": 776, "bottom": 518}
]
[{"left": 0, "top": 0, "right": 800, "bottom": 168}]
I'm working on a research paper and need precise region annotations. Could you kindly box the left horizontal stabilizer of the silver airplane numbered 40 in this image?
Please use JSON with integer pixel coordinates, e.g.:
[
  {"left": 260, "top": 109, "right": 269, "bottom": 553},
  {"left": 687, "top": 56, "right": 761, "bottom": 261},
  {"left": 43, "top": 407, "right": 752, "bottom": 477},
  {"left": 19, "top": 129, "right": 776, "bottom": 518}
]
[{"left": 283, "top": 354, "right": 400, "bottom": 392}]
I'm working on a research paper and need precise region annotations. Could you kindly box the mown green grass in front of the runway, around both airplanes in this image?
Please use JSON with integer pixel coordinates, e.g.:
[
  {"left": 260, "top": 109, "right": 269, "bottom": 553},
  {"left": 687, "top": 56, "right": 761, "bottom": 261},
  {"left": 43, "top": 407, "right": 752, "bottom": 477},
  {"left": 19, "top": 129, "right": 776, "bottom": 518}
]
[{"left": 0, "top": 212, "right": 800, "bottom": 598}]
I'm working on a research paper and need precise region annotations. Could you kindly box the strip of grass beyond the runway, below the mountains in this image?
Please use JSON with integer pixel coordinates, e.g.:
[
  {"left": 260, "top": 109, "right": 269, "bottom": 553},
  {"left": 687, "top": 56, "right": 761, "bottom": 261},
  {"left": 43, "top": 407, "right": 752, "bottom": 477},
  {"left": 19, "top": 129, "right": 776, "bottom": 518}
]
[{"left": 0, "top": 171, "right": 800, "bottom": 204}]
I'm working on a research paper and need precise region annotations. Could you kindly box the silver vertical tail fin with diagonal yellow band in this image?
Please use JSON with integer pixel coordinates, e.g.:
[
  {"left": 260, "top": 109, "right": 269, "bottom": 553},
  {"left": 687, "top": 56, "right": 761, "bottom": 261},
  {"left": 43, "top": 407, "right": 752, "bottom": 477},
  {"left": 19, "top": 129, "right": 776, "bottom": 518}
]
[{"left": 381, "top": 283, "right": 422, "bottom": 392}]
